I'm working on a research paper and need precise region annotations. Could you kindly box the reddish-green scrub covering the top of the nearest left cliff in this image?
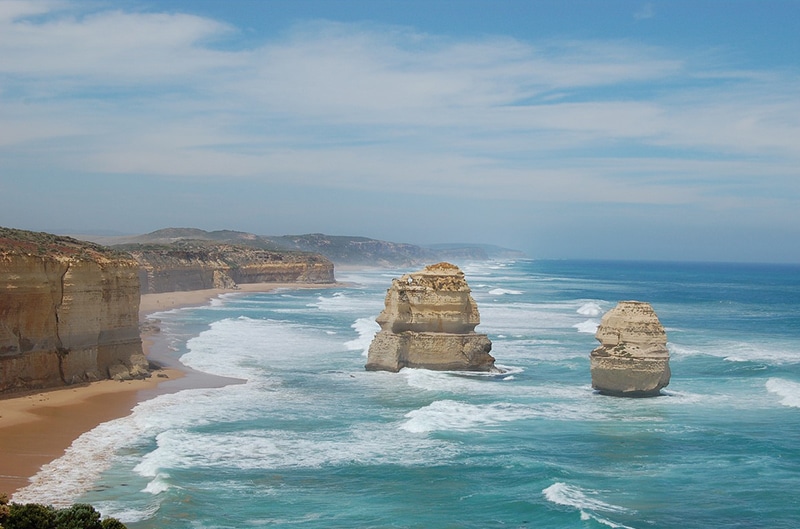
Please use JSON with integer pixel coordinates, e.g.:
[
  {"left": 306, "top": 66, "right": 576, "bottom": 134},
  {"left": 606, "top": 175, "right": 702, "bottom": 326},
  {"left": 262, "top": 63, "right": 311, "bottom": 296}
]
[{"left": 0, "top": 226, "right": 130, "bottom": 259}]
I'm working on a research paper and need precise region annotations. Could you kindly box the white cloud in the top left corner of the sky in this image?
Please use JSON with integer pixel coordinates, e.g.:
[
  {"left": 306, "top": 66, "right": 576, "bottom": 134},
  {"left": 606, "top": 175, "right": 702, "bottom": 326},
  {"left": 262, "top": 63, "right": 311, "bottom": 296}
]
[{"left": 0, "top": 2, "right": 237, "bottom": 82}]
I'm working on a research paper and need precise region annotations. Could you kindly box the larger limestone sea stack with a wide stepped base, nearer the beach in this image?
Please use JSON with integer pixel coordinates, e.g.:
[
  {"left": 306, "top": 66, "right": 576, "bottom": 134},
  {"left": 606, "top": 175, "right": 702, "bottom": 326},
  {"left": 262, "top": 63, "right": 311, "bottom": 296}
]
[{"left": 366, "top": 263, "right": 496, "bottom": 372}]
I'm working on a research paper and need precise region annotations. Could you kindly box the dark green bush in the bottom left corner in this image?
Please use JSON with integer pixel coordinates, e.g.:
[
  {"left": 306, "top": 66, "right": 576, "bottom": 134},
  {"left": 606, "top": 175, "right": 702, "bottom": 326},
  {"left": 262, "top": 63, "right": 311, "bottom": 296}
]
[{"left": 0, "top": 494, "right": 126, "bottom": 529}]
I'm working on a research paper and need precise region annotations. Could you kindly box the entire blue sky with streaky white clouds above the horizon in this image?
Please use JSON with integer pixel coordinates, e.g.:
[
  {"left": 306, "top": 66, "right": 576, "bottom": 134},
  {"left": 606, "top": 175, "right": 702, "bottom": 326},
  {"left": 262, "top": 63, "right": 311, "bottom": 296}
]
[{"left": 0, "top": 0, "right": 800, "bottom": 263}]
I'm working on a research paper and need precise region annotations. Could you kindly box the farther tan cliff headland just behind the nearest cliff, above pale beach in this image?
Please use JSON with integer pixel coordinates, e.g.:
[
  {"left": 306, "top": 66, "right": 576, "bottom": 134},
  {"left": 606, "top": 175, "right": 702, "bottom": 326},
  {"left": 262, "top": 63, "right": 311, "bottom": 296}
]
[{"left": 120, "top": 241, "right": 335, "bottom": 294}]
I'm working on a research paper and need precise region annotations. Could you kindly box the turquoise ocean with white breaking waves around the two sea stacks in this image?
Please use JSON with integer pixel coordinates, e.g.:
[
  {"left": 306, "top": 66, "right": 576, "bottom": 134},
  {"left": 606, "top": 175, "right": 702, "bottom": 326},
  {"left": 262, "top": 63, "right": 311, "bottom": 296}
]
[{"left": 15, "top": 260, "right": 800, "bottom": 529}]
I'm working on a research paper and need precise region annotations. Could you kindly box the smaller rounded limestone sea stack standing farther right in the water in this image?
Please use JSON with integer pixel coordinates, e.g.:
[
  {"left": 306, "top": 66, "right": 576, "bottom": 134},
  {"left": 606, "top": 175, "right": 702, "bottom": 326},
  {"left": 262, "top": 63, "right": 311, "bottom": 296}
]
[{"left": 590, "top": 301, "right": 670, "bottom": 397}]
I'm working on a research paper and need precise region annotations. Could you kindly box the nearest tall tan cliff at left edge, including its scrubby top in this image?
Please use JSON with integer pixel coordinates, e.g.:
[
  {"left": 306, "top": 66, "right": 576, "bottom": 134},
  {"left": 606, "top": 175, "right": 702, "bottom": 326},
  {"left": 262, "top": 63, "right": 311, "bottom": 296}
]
[{"left": 0, "top": 228, "right": 147, "bottom": 393}]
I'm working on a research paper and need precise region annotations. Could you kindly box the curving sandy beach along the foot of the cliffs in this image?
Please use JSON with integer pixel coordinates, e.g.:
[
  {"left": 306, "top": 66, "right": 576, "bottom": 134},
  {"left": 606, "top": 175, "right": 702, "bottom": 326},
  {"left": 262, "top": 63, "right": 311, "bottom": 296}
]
[{"left": 0, "top": 283, "right": 342, "bottom": 499}]
